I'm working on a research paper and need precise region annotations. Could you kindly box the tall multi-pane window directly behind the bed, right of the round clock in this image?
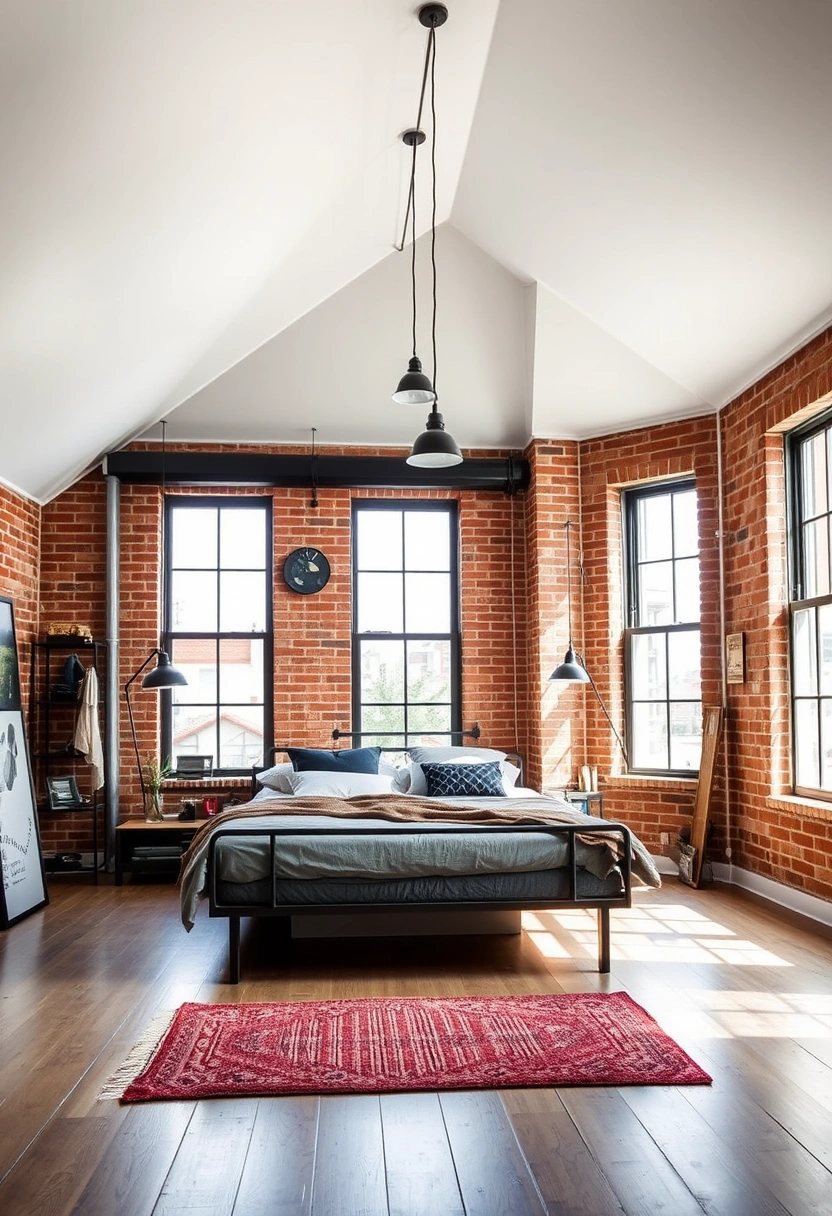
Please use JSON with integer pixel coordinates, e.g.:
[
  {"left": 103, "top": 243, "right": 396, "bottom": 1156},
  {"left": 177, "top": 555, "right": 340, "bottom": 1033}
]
[{"left": 353, "top": 502, "right": 461, "bottom": 747}]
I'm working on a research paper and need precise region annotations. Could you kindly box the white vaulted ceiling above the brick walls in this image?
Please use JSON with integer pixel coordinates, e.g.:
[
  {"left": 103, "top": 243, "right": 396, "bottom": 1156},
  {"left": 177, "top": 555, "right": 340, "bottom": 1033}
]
[{"left": 0, "top": 0, "right": 832, "bottom": 501}]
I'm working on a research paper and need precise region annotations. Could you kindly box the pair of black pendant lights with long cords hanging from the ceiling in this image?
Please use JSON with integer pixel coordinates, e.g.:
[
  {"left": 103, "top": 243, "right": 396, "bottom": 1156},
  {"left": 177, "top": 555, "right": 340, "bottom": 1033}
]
[{"left": 394, "top": 4, "right": 462, "bottom": 468}]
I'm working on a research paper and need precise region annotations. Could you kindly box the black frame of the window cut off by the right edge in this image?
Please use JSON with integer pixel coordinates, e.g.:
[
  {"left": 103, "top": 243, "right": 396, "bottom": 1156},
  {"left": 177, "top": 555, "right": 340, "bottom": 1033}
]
[{"left": 783, "top": 410, "right": 832, "bottom": 803}]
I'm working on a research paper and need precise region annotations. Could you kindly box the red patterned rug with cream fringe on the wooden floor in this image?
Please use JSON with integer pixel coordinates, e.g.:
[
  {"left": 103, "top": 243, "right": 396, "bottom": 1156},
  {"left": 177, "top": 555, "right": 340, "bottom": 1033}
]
[{"left": 108, "top": 992, "right": 710, "bottom": 1102}]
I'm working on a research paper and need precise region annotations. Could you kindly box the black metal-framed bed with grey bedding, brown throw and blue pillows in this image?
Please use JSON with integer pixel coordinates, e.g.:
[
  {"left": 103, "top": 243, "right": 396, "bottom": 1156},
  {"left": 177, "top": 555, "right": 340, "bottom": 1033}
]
[{"left": 180, "top": 747, "right": 660, "bottom": 984}]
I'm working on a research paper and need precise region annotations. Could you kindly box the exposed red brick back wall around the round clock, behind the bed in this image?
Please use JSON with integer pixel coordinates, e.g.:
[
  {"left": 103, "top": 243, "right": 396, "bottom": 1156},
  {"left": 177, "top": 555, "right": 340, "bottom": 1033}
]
[{"left": 37, "top": 445, "right": 528, "bottom": 848}]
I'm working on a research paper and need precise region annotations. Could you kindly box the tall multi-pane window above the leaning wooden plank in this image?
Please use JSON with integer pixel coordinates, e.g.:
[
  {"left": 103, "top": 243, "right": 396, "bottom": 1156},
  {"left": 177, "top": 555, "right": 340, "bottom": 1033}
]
[{"left": 624, "top": 482, "right": 702, "bottom": 775}]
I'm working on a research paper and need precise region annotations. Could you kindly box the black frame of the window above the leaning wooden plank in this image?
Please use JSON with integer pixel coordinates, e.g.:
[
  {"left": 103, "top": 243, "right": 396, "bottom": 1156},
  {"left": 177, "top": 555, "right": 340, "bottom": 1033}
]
[{"left": 622, "top": 477, "right": 702, "bottom": 777}]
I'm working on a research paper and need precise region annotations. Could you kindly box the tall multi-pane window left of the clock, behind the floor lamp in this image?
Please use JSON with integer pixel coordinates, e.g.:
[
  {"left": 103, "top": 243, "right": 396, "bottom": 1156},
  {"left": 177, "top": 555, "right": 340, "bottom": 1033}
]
[{"left": 162, "top": 496, "right": 274, "bottom": 773}]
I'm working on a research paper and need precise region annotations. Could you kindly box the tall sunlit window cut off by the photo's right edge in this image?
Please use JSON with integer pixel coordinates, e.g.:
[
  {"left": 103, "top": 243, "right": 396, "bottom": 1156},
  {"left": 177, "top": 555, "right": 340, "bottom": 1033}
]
[{"left": 786, "top": 413, "right": 832, "bottom": 798}]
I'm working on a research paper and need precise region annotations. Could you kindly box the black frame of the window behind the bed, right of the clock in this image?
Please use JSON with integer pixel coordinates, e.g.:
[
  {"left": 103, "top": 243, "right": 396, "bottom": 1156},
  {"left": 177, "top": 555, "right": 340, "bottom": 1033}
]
[{"left": 350, "top": 499, "right": 462, "bottom": 749}]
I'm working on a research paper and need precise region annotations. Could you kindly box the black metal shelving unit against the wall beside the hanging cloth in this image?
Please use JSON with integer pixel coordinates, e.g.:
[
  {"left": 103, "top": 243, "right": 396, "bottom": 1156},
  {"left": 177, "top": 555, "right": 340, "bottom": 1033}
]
[{"left": 29, "top": 637, "right": 108, "bottom": 885}]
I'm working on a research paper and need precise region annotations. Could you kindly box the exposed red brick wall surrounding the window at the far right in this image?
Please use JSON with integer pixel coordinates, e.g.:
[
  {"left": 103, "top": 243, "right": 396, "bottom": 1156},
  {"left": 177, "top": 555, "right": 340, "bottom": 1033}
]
[{"left": 723, "top": 330, "right": 832, "bottom": 900}]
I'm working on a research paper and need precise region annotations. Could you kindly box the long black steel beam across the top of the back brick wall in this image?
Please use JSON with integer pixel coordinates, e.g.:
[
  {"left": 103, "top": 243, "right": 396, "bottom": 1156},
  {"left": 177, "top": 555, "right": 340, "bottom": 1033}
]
[{"left": 103, "top": 449, "right": 529, "bottom": 492}]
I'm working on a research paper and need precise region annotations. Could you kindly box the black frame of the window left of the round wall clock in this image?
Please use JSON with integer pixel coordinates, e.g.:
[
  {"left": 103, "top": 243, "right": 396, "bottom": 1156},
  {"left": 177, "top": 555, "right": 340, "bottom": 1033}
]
[{"left": 159, "top": 494, "right": 275, "bottom": 777}]
